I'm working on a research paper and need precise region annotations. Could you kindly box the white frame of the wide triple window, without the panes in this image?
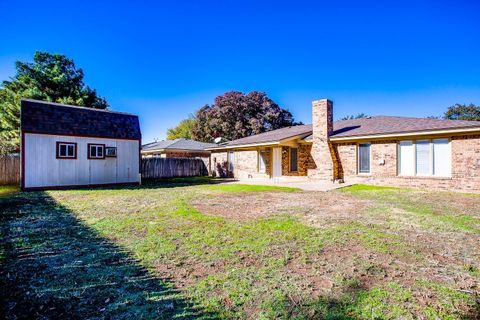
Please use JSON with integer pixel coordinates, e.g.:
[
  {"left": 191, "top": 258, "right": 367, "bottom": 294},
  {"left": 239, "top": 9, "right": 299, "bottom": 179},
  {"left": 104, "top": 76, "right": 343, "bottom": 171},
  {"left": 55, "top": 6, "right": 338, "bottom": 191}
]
[{"left": 397, "top": 138, "right": 452, "bottom": 178}]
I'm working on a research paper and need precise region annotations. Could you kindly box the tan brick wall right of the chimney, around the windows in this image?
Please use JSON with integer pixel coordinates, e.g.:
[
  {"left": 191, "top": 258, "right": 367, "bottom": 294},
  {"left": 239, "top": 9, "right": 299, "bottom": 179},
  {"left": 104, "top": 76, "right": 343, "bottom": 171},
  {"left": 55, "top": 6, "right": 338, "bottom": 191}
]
[{"left": 335, "top": 135, "right": 480, "bottom": 192}]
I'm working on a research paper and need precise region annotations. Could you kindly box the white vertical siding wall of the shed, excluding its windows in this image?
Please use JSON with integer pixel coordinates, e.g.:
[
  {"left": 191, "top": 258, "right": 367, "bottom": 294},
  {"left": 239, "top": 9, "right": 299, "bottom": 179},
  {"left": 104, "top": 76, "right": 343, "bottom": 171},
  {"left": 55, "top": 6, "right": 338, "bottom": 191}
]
[{"left": 24, "top": 133, "right": 140, "bottom": 188}]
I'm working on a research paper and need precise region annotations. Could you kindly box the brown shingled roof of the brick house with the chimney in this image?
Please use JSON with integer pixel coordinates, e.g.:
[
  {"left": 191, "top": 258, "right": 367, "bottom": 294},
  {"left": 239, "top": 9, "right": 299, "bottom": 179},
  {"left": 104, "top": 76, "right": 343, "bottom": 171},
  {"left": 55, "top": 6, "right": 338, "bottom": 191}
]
[{"left": 214, "top": 116, "right": 480, "bottom": 148}]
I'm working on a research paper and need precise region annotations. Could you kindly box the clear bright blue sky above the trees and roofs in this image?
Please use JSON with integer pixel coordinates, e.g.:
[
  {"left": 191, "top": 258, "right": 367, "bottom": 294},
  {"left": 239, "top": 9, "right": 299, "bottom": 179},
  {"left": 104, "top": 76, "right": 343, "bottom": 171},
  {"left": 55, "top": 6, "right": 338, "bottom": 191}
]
[{"left": 0, "top": 0, "right": 480, "bottom": 142}]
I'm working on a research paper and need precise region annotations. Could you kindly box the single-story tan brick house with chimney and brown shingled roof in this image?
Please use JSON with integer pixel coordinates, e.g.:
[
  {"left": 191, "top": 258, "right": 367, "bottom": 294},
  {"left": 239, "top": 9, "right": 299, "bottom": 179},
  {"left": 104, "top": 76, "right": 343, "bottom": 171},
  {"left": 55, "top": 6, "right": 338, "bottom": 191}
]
[{"left": 208, "top": 99, "right": 480, "bottom": 192}]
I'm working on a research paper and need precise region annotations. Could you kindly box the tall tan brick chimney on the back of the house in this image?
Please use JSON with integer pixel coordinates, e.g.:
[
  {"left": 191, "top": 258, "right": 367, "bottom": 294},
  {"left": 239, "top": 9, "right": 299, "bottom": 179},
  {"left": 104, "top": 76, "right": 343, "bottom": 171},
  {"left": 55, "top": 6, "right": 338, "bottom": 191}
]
[{"left": 308, "top": 99, "right": 334, "bottom": 180}]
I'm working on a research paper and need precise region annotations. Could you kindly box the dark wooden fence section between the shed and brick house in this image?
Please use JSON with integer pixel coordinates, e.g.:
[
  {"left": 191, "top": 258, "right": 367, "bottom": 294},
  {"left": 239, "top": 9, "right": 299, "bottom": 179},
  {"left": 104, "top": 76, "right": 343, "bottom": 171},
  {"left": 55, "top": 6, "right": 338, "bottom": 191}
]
[{"left": 142, "top": 157, "right": 208, "bottom": 179}]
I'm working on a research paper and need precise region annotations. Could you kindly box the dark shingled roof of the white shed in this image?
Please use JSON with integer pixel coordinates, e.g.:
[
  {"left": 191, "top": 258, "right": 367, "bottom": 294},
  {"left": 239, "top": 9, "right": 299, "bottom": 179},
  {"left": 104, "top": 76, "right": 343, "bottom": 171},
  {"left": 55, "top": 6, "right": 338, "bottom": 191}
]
[{"left": 20, "top": 99, "right": 142, "bottom": 139}]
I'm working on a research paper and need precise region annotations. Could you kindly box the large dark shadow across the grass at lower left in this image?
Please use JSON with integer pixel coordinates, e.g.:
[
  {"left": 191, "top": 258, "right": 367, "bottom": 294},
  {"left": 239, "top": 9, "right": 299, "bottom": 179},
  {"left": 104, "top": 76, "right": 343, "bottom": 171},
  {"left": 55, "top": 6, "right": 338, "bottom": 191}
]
[{"left": 0, "top": 192, "right": 217, "bottom": 319}]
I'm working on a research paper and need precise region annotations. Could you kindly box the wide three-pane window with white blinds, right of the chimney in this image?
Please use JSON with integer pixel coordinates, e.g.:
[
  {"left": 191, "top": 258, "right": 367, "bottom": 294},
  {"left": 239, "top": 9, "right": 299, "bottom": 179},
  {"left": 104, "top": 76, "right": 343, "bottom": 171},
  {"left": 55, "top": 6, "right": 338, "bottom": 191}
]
[{"left": 398, "top": 139, "right": 451, "bottom": 177}]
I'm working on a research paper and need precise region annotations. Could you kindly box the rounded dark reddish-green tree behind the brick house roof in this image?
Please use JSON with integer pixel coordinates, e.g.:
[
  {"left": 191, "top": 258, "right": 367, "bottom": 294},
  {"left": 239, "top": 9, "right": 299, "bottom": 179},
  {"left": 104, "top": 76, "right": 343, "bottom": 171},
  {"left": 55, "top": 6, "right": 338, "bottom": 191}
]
[{"left": 192, "top": 91, "right": 297, "bottom": 142}]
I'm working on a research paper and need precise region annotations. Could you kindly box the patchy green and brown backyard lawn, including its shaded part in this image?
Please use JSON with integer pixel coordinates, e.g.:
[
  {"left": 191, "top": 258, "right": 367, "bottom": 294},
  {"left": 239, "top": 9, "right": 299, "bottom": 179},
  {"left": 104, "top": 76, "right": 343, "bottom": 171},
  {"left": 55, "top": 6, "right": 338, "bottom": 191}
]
[{"left": 0, "top": 179, "right": 480, "bottom": 319}]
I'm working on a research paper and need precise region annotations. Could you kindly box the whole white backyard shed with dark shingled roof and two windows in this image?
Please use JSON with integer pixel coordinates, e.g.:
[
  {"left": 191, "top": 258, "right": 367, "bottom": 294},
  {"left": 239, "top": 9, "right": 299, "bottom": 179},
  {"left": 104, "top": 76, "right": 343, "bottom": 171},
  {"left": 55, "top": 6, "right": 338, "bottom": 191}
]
[{"left": 20, "top": 99, "right": 141, "bottom": 190}]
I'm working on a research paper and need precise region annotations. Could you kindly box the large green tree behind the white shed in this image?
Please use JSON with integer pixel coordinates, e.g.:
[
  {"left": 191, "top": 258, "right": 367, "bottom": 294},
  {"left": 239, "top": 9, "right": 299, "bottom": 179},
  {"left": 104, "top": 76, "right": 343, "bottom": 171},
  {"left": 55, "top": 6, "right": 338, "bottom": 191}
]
[{"left": 0, "top": 52, "right": 108, "bottom": 154}]
